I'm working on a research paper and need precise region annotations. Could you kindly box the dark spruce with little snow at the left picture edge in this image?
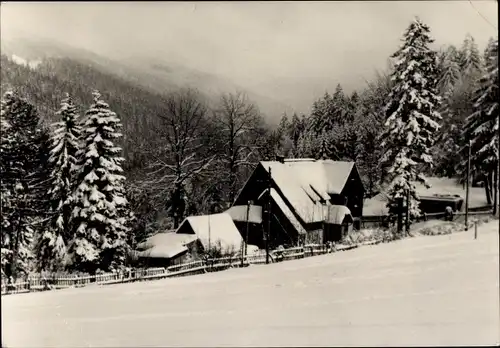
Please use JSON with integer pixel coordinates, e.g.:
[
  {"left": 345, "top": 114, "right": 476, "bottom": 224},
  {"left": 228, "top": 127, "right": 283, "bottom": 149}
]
[{"left": 0, "top": 92, "right": 41, "bottom": 278}]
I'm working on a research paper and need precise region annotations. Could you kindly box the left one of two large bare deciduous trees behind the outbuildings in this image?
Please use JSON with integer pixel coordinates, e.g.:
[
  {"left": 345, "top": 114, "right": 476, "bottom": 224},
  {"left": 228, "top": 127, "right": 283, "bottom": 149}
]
[{"left": 143, "top": 89, "right": 215, "bottom": 228}]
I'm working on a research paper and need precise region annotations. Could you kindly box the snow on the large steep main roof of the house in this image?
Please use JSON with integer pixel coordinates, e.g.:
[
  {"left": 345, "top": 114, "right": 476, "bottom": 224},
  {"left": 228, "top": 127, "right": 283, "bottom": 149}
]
[{"left": 260, "top": 159, "right": 354, "bottom": 223}]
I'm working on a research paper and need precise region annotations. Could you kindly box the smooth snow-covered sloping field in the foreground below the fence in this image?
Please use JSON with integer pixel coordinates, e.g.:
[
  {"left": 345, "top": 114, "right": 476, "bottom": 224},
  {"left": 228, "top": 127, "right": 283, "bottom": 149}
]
[{"left": 2, "top": 221, "right": 500, "bottom": 347}]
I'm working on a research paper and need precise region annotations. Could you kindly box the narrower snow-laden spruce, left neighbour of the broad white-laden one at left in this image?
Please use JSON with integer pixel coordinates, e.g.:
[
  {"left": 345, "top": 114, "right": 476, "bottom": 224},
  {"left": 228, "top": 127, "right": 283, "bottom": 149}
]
[{"left": 35, "top": 94, "right": 81, "bottom": 271}]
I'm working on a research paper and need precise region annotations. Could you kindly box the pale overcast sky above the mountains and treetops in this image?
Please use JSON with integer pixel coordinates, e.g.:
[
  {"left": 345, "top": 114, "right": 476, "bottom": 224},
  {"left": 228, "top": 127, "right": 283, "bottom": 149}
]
[{"left": 1, "top": 0, "right": 498, "bottom": 111}]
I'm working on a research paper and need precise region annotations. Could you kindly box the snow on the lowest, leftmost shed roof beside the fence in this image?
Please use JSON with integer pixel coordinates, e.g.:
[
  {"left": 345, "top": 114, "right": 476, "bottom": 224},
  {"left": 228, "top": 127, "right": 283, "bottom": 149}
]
[{"left": 137, "top": 232, "right": 196, "bottom": 259}]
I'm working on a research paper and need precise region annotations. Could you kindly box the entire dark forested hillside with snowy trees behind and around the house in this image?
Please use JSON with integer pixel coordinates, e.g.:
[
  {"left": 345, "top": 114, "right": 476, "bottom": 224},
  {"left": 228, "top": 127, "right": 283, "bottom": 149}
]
[{"left": 1, "top": 20, "right": 499, "bottom": 280}]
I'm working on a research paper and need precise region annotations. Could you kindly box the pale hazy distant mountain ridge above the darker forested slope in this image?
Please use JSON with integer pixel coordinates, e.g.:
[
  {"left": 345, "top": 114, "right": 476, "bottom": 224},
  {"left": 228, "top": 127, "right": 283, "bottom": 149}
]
[{"left": 1, "top": 37, "right": 293, "bottom": 124}]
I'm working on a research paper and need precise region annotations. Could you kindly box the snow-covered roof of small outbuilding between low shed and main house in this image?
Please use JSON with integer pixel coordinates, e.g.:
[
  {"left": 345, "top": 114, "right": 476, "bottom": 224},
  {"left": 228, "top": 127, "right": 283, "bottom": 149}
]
[{"left": 181, "top": 213, "right": 243, "bottom": 250}]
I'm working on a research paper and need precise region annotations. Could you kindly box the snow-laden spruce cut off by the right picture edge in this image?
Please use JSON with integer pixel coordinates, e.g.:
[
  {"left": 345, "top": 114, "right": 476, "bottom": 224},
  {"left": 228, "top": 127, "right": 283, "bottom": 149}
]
[{"left": 463, "top": 39, "right": 500, "bottom": 211}]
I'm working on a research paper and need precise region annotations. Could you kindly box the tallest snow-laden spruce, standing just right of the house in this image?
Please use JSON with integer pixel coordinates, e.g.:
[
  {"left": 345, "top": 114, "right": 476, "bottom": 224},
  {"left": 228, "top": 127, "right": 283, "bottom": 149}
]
[{"left": 380, "top": 18, "right": 441, "bottom": 217}]
